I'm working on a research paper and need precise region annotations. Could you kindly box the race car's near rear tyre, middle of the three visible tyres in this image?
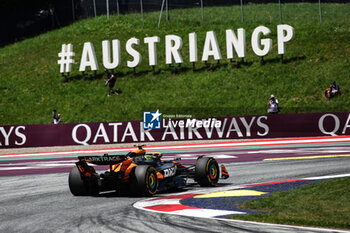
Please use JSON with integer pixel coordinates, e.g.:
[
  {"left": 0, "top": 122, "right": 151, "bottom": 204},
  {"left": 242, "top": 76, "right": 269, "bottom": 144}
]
[{"left": 130, "top": 165, "right": 158, "bottom": 196}]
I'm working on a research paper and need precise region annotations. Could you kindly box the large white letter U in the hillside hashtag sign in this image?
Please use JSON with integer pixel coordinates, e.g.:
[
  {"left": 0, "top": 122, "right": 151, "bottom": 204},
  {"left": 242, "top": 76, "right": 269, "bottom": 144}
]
[{"left": 102, "top": 40, "right": 121, "bottom": 70}]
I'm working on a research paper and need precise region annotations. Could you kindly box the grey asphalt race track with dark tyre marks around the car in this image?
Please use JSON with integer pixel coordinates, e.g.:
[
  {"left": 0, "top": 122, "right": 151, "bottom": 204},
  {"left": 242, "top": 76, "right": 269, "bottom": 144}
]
[{"left": 0, "top": 139, "right": 350, "bottom": 233}]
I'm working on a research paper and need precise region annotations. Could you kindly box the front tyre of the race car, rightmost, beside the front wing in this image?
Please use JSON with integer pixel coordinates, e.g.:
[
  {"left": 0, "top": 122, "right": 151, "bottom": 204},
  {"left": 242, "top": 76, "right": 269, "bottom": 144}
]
[{"left": 195, "top": 157, "right": 220, "bottom": 187}]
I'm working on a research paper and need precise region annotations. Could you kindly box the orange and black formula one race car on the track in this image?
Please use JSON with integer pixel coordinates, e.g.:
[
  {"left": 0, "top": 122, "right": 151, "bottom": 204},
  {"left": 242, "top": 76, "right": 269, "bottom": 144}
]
[{"left": 69, "top": 145, "right": 229, "bottom": 196}]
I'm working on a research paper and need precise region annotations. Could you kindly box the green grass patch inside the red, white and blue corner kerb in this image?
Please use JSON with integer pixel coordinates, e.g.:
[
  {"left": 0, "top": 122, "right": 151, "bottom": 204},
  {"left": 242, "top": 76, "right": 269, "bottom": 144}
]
[{"left": 233, "top": 178, "right": 350, "bottom": 229}]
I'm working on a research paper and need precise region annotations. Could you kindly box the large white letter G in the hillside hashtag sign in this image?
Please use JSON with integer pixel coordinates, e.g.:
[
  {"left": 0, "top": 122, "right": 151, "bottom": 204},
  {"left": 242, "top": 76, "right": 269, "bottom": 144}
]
[{"left": 252, "top": 26, "right": 272, "bottom": 57}]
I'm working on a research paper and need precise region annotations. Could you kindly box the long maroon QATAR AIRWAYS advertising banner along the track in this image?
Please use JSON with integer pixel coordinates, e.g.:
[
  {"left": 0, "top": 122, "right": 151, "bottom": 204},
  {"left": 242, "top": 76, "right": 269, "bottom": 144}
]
[{"left": 0, "top": 111, "right": 350, "bottom": 149}]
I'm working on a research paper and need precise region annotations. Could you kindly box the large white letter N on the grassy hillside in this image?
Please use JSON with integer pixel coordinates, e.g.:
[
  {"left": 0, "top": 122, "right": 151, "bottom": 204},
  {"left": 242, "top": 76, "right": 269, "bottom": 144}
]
[{"left": 226, "top": 28, "right": 246, "bottom": 59}]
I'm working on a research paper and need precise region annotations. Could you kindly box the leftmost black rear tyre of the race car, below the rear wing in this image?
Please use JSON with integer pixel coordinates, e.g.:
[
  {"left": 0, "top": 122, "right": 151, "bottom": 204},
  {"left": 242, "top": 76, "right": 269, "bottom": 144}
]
[{"left": 68, "top": 167, "right": 98, "bottom": 196}]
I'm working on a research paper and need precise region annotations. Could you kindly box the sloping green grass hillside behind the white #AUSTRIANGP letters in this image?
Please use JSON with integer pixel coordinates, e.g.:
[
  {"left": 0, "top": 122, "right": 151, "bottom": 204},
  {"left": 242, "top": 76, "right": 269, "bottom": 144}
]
[{"left": 0, "top": 3, "right": 350, "bottom": 125}]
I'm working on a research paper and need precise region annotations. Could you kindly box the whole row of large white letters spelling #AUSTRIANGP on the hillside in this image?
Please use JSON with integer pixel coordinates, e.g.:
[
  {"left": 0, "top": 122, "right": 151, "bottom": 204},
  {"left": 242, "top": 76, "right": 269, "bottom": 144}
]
[{"left": 57, "top": 24, "right": 296, "bottom": 73}]
